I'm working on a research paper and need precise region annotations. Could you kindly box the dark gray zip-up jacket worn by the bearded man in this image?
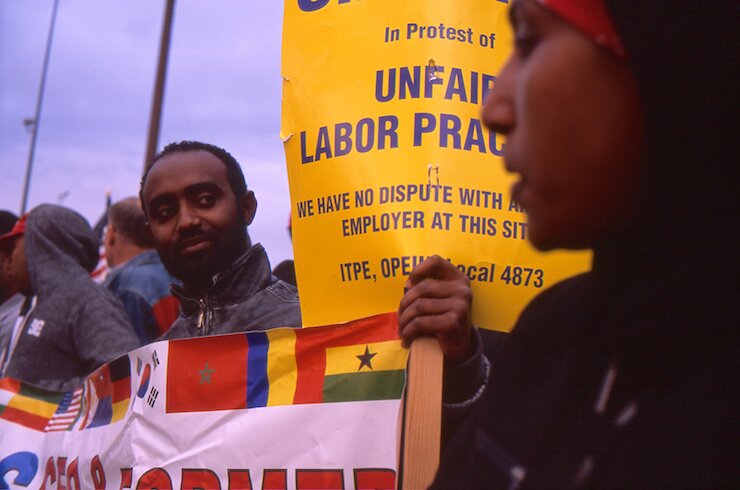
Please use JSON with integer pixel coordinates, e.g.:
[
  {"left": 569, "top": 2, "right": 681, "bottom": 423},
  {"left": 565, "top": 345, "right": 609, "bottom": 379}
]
[{"left": 161, "top": 244, "right": 301, "bottom": 339}]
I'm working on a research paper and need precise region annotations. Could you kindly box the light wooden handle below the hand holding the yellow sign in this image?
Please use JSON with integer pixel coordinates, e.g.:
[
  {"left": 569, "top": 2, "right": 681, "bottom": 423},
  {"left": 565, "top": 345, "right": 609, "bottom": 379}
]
[{"left": 399, "top": 337, "right": 444, "bottom": 490}]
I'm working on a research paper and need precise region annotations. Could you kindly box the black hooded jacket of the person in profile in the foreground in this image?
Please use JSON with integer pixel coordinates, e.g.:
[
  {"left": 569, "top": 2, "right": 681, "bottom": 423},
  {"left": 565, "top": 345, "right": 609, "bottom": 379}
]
[{"left": 434, "top": 0, "right": 740, "bottom": 488}]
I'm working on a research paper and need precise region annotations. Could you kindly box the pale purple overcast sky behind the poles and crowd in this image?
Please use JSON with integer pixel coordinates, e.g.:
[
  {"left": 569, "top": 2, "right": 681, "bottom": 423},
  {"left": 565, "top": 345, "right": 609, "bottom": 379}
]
[{"left": 0, "top": 0, "right": 292, "bottom": 265}]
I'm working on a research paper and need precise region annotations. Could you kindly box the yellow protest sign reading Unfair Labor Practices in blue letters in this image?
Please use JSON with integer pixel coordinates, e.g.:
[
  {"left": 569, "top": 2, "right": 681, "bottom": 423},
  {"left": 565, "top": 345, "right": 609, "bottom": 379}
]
[{"left": 281, "top": 0, "right": 589, "bottom": 330}]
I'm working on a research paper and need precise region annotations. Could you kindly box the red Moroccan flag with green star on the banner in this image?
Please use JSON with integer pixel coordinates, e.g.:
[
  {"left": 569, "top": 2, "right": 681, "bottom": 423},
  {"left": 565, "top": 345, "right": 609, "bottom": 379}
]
[{"left": 166, "top": 335, "right": 249, "bottom": 413}]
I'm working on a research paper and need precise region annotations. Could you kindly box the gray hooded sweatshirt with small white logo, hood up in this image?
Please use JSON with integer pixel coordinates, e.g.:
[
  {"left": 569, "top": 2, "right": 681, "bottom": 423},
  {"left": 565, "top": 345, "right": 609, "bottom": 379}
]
[{"left": 3, "top": 204, "right": 139, "bottom": 391}]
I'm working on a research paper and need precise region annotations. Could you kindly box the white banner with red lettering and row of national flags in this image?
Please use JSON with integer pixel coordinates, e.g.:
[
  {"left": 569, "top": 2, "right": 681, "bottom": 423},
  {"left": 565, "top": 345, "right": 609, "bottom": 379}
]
[{"left": 0, "top": 313, "right": 408, "bottom": 490}]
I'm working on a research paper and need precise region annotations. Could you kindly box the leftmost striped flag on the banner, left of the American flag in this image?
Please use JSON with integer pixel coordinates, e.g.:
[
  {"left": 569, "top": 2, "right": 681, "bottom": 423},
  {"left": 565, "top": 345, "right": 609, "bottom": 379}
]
[{"left": 0, "top": 378, "right": 64, "bottom": 431}]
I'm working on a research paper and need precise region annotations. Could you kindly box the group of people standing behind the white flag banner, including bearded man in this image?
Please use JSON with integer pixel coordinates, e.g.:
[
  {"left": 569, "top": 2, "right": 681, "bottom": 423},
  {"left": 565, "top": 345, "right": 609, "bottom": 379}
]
[{"left": 0, "top": 141, "right": 301, "bottom": 391}]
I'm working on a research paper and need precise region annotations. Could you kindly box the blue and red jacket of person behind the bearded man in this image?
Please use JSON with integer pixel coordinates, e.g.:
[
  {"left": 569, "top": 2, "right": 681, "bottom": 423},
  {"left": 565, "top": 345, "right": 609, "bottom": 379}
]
[{"left": 104, "top": 250, "right": 179, "bottom": 344}]
